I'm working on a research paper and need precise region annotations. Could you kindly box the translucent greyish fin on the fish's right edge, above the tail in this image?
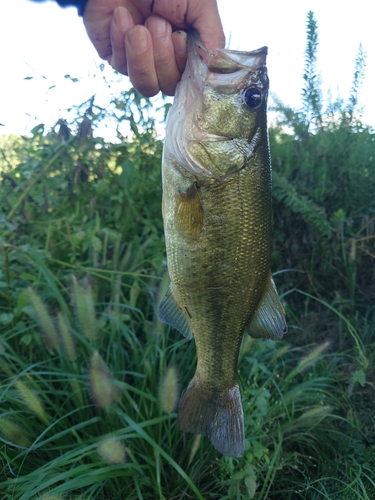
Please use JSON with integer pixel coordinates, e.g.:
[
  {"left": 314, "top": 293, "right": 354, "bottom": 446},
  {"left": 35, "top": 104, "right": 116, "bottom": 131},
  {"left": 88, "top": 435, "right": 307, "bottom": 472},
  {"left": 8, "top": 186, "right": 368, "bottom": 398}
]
[{"left": 246, "top": 277, "right": 288, "bottom": 340}]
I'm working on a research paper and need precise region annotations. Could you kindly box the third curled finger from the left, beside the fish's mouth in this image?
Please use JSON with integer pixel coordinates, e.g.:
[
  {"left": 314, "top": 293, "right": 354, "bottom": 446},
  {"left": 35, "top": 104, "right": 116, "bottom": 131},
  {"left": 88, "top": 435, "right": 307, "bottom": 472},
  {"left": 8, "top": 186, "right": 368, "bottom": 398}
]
[{"left": 145, "top": 16, "right": 181, "bottom": 95}]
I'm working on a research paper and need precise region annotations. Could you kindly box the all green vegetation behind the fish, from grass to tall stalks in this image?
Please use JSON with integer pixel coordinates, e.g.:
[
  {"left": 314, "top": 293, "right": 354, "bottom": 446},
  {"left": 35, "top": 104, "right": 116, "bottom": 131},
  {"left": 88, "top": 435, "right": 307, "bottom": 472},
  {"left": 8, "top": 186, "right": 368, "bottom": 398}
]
[{"left": 0, "top": 12, "right": 375, "bottom": 500}]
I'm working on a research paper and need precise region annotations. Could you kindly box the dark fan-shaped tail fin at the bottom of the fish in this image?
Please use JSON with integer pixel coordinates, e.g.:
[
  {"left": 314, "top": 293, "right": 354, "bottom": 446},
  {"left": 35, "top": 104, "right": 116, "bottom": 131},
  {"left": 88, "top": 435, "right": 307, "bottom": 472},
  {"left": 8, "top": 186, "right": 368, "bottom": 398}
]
[{"left": 177, "top": 375, "right": 245, "bottom": 457}]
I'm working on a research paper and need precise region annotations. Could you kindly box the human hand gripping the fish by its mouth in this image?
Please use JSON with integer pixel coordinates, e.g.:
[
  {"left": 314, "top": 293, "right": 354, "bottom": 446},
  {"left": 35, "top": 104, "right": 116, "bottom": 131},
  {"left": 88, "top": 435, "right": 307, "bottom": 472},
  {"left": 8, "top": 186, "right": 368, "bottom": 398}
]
[{"left": 83, "top": 0, "right": 225, "bottom": 96}]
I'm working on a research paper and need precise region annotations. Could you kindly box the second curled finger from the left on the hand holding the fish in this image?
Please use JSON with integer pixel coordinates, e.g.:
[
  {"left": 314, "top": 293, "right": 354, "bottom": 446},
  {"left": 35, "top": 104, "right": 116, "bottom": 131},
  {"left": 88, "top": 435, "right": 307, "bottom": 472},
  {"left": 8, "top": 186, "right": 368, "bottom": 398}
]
[{"left": 125, "top": 26, "right": 160, "bottom": 97}]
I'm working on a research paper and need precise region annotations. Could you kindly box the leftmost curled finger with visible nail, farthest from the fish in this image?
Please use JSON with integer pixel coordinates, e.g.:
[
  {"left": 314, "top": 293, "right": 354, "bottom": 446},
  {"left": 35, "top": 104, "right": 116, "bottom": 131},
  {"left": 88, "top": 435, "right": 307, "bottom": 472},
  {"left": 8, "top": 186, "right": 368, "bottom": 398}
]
[{"left": 109, "top": 6, "right": 134, "bottom": 75}]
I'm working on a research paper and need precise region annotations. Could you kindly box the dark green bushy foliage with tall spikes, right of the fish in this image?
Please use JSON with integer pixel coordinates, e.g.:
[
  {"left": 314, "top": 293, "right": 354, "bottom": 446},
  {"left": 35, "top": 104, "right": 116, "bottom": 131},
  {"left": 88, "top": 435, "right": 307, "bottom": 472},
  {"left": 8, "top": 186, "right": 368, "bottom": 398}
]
[{"left": 270, "top": 12, "right": 375, "bottom": 315}]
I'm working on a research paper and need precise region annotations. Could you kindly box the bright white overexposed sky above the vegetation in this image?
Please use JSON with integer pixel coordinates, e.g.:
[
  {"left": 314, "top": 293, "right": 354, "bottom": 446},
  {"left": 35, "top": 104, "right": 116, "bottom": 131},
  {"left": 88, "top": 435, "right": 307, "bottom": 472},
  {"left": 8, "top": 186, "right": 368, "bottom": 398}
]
[{"left": 0, "top": 0, "right": 375, "bottom": 140}]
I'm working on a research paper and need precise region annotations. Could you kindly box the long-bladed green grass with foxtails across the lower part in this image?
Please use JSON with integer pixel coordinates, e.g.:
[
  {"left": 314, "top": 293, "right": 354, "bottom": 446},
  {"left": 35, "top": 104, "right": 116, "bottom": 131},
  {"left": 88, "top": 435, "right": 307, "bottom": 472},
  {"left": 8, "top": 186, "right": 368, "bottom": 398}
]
[{"left": 0, "top": 248, "right": 375, "bottom": 500}]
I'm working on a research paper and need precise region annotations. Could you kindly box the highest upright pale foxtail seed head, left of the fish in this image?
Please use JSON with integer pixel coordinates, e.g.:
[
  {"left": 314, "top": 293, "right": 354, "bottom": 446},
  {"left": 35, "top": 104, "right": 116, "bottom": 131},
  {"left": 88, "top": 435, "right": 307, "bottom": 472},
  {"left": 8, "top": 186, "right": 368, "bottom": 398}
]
[{"left": 73, "top": 277, "right": 98, "bottom": 340}]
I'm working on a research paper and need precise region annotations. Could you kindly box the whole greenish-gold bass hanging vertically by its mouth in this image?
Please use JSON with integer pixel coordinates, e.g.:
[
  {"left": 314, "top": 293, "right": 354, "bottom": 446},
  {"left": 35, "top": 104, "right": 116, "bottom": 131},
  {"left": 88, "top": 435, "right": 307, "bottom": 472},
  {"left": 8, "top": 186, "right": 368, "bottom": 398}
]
[{"left": 158, "top": 31, "right": 287, "bottom": 457}]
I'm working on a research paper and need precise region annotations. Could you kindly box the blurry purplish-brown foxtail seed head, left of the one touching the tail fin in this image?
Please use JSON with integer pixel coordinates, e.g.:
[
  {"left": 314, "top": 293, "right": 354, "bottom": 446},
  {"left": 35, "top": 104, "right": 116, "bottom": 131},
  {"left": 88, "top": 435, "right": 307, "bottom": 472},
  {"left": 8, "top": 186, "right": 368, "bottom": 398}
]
[{"left": 89, "top": 351, "right": 117, "bottom": 409}]
